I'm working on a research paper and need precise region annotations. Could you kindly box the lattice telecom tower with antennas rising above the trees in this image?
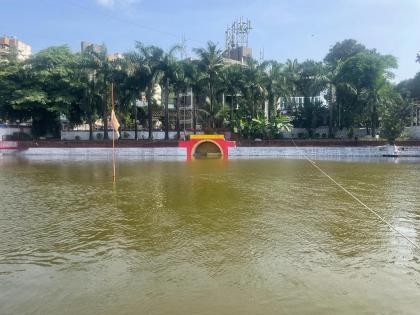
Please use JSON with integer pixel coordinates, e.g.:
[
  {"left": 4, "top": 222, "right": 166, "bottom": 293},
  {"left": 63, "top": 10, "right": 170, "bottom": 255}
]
[{"left": 225, "top": 17, "right": 252, "bottom": 63}]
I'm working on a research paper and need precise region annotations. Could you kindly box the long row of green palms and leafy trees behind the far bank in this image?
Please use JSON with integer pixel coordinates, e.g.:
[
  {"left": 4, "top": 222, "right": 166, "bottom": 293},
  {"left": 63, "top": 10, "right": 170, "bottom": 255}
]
[{"left": 0, "top": 39, "right": 420, "bottom": 141}]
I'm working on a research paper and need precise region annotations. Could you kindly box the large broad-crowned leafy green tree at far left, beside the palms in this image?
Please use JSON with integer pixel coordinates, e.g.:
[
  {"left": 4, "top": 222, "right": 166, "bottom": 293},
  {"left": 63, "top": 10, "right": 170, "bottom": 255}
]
[{"left": 0, "top": 46, "right": 78, "bottom": 137}]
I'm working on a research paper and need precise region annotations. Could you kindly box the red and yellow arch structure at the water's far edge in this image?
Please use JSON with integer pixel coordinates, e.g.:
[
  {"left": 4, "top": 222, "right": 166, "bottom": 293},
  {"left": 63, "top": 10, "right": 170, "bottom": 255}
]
[{"left": 178, "top": 135, "right": 236, "bottom": 158}]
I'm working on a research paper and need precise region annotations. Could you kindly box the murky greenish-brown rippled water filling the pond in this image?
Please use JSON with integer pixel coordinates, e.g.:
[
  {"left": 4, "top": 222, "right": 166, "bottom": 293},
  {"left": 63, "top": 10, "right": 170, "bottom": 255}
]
[{"left": 0, "top": 158, "right": 420, "bottom": 314}]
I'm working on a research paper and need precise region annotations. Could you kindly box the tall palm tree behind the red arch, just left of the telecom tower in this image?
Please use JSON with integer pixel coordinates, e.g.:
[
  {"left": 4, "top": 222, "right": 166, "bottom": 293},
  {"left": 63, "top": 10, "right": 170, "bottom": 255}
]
[{"left": 194, "top": 42, "right": 224, "bottom": 129}]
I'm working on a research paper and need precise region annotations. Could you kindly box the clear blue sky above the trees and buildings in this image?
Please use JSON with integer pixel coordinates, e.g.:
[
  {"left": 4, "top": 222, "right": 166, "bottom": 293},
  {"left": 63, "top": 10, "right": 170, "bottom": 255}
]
[{"left": 0, "top": 0, "right": 420, "bottom": 81}]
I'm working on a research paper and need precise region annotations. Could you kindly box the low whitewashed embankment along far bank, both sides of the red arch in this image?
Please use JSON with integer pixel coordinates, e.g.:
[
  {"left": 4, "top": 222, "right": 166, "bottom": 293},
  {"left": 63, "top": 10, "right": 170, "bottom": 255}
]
[{"left": 2, "top": 140, "right": 420, "bottom": 159}]
